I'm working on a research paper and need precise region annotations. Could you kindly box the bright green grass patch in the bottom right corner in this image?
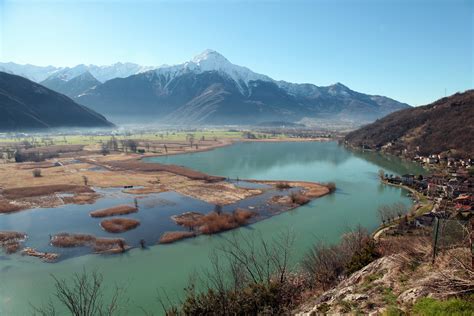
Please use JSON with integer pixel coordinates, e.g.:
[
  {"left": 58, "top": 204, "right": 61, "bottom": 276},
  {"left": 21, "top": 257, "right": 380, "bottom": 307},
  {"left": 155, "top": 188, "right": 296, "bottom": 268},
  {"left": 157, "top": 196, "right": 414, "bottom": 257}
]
[{"left": 412, "top": 295, "right": 474, "bottom": 316}]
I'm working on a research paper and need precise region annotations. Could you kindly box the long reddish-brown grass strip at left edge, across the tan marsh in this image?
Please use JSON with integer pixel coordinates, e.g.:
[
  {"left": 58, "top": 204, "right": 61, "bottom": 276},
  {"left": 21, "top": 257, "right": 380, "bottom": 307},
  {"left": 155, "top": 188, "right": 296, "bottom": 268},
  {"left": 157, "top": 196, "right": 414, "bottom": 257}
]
[{"left": 2, "top": 184, "right": 94, "bottom": 200}]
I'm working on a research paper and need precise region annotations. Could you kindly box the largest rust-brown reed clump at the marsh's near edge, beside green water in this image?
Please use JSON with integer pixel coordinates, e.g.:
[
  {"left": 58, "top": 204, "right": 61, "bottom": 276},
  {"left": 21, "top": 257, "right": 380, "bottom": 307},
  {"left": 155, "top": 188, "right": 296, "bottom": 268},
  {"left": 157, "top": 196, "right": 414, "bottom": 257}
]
[{"left": 173, "top": 209, "right": 255, "bottom": 234}]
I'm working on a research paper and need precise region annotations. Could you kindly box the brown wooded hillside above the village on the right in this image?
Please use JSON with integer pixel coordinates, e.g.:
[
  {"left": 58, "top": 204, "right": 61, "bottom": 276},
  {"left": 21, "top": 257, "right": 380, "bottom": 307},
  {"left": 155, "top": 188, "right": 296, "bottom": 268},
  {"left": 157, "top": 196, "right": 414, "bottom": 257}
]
[{"left": 346, "top": 90, "right": 474, "bottom": 157}]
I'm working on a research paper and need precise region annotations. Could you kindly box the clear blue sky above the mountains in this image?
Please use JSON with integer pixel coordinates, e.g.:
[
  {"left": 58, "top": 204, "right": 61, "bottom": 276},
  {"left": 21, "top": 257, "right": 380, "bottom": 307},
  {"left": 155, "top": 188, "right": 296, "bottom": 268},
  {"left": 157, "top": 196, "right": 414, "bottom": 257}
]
[{"left": 0, "top": 0, "right": 474, "bottom": 105}]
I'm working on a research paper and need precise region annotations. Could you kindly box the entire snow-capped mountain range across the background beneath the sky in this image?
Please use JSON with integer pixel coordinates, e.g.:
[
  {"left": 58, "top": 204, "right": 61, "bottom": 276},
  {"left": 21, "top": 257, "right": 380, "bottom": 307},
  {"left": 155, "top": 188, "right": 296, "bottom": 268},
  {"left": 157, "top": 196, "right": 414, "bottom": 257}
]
[{"left": 0, "top": 50, "right": 409, "bottom": 124}]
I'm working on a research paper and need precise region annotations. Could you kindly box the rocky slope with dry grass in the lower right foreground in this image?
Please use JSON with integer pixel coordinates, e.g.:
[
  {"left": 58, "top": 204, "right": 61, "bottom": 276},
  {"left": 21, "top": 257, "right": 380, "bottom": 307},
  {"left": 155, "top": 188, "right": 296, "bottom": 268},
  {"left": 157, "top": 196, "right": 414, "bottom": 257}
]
[{"left": 294, "top": 246, "right": 474, "bottom": 315}]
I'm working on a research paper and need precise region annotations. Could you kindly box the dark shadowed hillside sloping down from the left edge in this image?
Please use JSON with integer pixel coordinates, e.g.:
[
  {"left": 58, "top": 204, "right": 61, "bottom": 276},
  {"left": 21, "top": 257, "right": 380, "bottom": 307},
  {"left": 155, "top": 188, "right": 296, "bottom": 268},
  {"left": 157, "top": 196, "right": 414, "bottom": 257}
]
[{"left": 0, "top": 72, "right": 113, "bottom": 131}]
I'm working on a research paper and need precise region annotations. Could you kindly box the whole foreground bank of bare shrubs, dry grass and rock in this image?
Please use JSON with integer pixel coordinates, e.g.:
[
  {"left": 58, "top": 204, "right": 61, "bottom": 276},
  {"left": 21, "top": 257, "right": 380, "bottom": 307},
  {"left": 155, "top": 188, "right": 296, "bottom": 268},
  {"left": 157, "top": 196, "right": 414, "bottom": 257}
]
[{"left": 33, "top": 223, "right": 474, "bottom": 316}]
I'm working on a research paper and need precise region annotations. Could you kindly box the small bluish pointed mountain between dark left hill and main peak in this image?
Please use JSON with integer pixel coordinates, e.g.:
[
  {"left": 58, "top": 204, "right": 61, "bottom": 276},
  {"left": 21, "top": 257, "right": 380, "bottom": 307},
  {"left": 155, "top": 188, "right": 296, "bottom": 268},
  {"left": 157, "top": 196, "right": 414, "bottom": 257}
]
[{"left": 41, "top": 71, "right": 101, "bottom": 98}]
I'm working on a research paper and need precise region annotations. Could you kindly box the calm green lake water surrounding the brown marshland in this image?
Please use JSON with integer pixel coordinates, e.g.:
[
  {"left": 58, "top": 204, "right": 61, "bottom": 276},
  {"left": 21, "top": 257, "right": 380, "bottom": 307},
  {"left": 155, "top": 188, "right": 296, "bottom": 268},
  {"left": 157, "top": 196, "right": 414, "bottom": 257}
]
[{"left": 0, "top": 142, "right": 424, "bottom": 315}]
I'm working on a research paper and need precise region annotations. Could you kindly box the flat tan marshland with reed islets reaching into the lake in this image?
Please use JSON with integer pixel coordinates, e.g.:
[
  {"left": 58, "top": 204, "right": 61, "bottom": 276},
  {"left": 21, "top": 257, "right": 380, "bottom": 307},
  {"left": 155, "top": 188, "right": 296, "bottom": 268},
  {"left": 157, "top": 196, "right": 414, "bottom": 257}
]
[{"left": 0, "top": 138, "right": 332, "bottom": 259}]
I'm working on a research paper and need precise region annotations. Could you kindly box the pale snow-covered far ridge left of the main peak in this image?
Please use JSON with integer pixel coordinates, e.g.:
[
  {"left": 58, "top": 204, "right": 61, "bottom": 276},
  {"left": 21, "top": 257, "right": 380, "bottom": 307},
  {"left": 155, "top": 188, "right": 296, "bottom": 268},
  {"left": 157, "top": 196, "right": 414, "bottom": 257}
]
[{"left": 0, "top": 63, "right": 156, "bottom": 83}]
